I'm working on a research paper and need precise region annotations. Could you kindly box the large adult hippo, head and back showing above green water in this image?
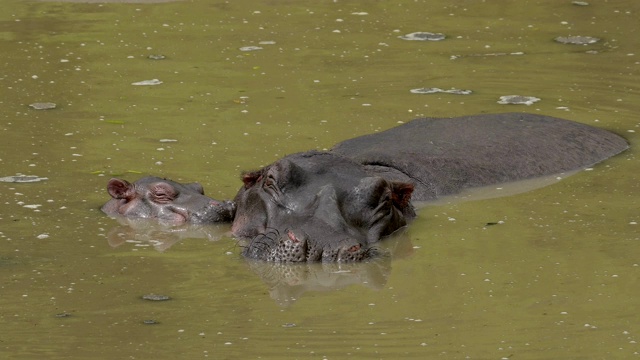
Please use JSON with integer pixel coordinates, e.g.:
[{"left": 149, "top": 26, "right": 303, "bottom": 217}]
[{"left": 232, "top": 113, "right": 628, "bottom": 262}]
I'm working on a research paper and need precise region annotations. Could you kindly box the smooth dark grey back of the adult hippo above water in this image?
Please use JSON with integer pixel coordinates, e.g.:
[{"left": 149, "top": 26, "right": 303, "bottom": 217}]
[{"left": 331, "top": 113, "right": 628, "bottom": 201}]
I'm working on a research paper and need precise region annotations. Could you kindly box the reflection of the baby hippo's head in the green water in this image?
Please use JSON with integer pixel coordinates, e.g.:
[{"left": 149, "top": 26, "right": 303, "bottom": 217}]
[{"left": 107, "top": 217, "right": 230, "bottom": 252}]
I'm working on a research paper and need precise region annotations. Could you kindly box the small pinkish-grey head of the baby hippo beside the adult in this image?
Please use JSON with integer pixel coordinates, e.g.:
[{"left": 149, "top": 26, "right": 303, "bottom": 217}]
[{"left": 101, "top": 176, "right": 235, "bottom": 224}]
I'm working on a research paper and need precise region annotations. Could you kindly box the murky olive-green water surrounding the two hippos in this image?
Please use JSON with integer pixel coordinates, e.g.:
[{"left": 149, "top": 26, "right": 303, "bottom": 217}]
[{"left": 0, "top": 0, "right": 640, "bottom": 359}]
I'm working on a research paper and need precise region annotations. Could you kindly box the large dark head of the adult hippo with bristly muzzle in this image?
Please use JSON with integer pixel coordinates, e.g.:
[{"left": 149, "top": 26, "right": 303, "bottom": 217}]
[{"left": 232, "top": 151, "right": 415, "bottom": 262}]
